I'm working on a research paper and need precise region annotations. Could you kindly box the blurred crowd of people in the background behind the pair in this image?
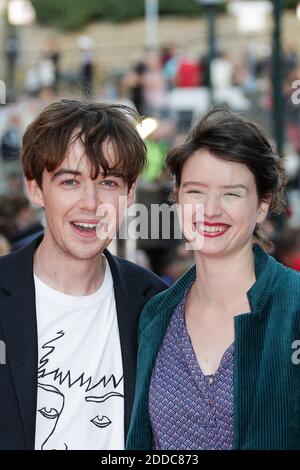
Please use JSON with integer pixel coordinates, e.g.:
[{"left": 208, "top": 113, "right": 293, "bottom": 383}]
[{"left": 0, "top": 36, "right": 300, "bottom": 284}]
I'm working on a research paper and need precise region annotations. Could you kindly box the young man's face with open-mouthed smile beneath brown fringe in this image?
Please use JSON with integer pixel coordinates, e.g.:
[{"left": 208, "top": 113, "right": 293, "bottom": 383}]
[{"left": 27, "top": 140, "right": 134, "bottom": 260}]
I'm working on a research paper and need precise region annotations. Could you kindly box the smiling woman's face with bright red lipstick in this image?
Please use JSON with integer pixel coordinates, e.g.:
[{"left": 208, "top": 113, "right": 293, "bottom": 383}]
[{"left": 177, "top": 150, "right": 269, "bottom": 257}]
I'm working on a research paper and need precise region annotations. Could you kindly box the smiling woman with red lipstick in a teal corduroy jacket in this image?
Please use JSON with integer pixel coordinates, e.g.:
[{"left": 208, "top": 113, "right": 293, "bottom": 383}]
[{"left": 127, "top": 111, "right": 300, "bottom": 450}]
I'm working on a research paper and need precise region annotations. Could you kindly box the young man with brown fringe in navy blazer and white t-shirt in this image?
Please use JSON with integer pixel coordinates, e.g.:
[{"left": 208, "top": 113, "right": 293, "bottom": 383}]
[{"left": 0, "top": 100, "right": 165, "bottom": 449}]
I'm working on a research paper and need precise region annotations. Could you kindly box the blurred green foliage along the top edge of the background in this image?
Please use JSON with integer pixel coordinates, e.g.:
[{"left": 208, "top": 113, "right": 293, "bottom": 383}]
[{"left": 31, "top": 0, "right": 298, "bottom": 30}]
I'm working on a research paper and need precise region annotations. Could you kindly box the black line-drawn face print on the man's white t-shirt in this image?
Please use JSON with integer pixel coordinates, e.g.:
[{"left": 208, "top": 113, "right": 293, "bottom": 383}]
[{"left": 36, "top": 331, "right": 124, "bottom": 450}]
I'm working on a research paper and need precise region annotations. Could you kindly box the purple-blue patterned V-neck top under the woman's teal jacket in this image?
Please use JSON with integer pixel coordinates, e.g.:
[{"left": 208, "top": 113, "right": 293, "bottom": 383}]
[{"left": 149, "top": 289, "right": 234, "bottom": 450}]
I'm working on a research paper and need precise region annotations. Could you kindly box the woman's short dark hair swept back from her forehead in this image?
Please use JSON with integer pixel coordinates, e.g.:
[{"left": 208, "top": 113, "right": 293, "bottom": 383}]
[{"left": 167, "top": 109, "right": 286, "bottom": 250}]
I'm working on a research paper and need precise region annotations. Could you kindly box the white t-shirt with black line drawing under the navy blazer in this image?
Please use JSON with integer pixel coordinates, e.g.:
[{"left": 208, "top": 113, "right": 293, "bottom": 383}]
[{"left": 34, "top": 261, "right": 124, "bottom": 450}]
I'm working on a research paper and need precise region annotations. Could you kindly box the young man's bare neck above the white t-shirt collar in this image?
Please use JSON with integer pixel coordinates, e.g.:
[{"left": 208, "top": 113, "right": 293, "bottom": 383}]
[{"left": 34, "top": 240, "right": 105, "bottom": 296}]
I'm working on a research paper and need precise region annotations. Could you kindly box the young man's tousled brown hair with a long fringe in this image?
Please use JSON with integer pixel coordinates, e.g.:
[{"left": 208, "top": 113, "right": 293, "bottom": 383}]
[{"left": 22, "top": 100, "right": 146, "bottom": 188}]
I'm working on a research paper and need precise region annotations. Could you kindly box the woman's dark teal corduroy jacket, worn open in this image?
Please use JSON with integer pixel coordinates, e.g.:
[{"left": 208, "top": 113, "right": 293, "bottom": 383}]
[{"left": 126, "top": 245, "right": 300, "bottom": 450}]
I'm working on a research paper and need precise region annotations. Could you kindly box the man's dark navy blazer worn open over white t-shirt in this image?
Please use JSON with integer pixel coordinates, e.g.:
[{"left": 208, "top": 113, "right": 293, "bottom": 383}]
[{"left": 0, "top": 237, "right": 166, "bottom": 450}]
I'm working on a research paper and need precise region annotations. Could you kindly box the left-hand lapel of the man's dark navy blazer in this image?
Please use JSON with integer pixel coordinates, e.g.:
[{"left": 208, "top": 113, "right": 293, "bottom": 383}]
[{"left": 0, "top": 235, "right": 41, "bottom": 449}]
